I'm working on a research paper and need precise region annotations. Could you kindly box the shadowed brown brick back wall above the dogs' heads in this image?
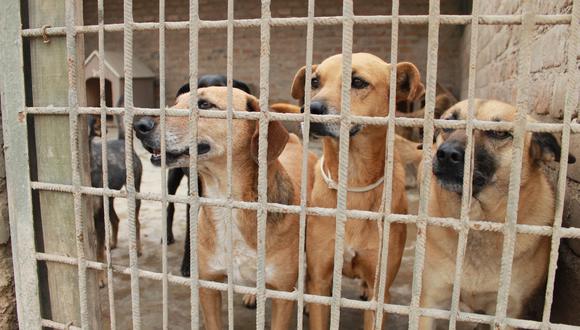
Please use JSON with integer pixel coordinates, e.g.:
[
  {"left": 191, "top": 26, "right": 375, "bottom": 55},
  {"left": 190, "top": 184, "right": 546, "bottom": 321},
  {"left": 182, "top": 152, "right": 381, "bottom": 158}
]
[{"left": 84, "top": 0, "right": 463, "bottom": 102}]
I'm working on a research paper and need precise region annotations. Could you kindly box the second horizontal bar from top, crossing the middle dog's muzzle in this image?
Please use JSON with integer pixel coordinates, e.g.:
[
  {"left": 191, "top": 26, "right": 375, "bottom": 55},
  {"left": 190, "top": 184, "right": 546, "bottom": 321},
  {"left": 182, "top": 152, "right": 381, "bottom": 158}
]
[{"left": 25, "top": 107, "right": 580, "bottom": 133}]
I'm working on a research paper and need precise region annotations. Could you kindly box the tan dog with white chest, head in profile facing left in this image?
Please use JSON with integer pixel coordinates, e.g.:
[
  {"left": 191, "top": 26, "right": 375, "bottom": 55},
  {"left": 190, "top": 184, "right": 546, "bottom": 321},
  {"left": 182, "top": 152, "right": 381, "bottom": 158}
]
[{"left": 135, "top": 87, "right": 316, "bottom": 329}]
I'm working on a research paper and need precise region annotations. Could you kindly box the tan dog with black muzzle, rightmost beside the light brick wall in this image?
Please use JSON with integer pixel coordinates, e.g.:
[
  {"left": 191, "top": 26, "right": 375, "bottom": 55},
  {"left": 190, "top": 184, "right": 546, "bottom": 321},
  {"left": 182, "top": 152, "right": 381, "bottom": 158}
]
[{"left": 420, "top": 100, "right": 574, "bottom": 329}]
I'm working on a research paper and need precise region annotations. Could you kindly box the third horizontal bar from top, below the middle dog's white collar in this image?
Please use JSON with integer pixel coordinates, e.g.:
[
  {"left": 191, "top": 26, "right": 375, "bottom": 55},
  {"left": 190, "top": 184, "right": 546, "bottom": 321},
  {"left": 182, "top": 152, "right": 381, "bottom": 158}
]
[{"left": 30, "top": 181, "right": 580, "bottom": 238}]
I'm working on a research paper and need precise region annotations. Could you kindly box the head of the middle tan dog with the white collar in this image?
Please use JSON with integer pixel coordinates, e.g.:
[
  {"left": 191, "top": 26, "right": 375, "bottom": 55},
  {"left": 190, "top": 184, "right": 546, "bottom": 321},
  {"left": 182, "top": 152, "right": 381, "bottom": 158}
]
[{"left": 292, "top": 53, "right": 423, "bottom": 138}]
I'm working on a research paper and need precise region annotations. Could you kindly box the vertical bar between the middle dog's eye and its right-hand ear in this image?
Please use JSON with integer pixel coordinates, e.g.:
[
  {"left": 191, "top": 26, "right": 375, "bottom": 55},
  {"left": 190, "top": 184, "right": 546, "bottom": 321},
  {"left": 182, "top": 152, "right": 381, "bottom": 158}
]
[{"left": 373, "top": 0, "right": 399, "bottom": 330}]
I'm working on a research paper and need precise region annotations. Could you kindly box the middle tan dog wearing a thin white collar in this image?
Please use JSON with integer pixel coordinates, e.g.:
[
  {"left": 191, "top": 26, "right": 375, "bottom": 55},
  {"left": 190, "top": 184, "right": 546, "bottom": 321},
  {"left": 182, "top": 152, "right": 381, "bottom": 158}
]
[{"left": 292, "top": 53, "right": 423, "bottom": 329}]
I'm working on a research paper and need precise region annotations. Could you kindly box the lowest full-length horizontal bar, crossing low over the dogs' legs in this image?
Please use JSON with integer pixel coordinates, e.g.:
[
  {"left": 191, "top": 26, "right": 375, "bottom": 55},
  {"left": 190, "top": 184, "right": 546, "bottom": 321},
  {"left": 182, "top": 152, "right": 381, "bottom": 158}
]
[{"left": 36, "top": 252, "right": 569, "bottom": 329}]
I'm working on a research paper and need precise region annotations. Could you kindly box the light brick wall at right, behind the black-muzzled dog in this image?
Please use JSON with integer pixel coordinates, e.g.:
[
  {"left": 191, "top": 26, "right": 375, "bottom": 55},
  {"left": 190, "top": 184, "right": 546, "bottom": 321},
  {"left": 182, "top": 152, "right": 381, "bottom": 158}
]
[{"left": 461, "top": 0, "right": 580, "bottom": 325}]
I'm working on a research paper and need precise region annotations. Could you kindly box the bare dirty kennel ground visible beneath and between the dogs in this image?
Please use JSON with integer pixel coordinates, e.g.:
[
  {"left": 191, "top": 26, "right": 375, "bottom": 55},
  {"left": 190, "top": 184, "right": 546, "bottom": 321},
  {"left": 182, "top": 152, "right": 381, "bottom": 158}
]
[{"left": 101, "top": 130, "right": 417, "bottom": 329}]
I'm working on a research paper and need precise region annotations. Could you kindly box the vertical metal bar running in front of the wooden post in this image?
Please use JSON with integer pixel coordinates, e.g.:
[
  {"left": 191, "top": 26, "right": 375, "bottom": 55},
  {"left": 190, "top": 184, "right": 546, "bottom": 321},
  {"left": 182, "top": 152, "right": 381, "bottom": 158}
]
[{"left": 65, "top": 0, "right": 89, "bottom": 329}]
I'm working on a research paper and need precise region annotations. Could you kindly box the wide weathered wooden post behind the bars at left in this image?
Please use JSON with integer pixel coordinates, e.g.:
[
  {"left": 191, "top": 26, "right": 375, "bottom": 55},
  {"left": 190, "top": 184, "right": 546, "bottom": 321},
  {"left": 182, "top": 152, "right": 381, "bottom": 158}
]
[{"left": 28, "top": 0, "right": 102, "bottom": 329}]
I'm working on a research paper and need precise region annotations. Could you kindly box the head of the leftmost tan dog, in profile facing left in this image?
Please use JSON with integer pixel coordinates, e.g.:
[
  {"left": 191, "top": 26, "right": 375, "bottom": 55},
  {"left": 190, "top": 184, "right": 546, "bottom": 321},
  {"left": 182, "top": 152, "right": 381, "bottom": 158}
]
[{"left": 134, "top": 87, "right": 289, "bottom": 168}]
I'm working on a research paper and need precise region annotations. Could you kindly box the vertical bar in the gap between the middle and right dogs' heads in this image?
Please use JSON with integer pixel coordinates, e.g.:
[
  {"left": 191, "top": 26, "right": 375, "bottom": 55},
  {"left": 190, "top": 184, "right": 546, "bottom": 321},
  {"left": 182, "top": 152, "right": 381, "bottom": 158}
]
[{"left": 409, "top": 0, "right": 440, "bottom": 329}]
